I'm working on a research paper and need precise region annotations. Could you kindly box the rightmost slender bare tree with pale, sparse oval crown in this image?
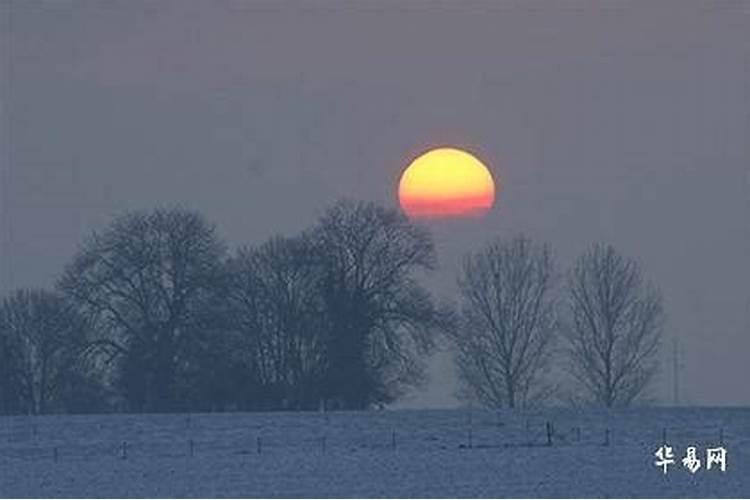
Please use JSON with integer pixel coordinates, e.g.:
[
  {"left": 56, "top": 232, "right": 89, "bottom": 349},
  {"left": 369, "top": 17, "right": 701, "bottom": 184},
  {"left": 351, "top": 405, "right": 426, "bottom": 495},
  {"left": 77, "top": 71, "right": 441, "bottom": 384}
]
[{"left": 566, "top": 244, "right": 663, "bottom": 407}]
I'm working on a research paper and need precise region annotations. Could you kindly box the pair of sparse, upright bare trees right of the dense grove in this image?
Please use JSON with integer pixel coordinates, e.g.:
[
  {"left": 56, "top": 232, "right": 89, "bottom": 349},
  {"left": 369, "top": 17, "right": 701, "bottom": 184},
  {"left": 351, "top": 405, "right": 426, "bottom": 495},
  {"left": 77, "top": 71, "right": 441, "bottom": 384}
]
[{"left": 452, "top": 237, "right": 663, "bottom": 408}]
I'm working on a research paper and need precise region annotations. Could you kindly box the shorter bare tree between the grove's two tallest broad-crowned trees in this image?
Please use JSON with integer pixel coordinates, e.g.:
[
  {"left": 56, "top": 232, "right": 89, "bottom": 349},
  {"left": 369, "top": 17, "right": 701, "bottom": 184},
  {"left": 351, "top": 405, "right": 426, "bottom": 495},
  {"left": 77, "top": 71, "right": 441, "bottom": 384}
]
[{"left": 228, "top": 237, "right": 326, "bottom": 409}]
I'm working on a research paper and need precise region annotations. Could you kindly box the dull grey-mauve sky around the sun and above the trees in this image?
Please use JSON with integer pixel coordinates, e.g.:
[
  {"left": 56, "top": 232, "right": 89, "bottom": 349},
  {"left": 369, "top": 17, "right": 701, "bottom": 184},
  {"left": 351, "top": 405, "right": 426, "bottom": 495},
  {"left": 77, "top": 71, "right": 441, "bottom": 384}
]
[{"left": 0, "top": 0, "right": 750, "bottom": 407}]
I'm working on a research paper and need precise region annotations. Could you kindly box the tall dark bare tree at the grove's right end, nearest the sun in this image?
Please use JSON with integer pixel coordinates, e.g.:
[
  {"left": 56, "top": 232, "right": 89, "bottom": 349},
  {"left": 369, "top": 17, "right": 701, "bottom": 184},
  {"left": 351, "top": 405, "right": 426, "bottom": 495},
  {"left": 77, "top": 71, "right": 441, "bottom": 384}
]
[{"left": 309, "top": 200, "right": 441, "bottom": 408}]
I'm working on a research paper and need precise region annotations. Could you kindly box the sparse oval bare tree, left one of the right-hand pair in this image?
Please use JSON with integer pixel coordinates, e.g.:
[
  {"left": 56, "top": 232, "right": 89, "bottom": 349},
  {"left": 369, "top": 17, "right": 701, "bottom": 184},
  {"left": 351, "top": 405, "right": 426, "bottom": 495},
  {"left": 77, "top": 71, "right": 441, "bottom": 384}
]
[{"left": 453, "top": 236, "right": 556, "bottom": 408}]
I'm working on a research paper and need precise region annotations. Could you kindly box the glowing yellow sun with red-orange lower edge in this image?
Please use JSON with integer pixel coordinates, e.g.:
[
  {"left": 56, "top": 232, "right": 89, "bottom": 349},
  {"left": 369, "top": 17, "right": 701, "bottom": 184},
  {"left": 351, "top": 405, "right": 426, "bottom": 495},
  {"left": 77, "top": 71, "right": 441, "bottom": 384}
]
[{"left": 398, "top": 147, "right": 495, "bottom": 218}]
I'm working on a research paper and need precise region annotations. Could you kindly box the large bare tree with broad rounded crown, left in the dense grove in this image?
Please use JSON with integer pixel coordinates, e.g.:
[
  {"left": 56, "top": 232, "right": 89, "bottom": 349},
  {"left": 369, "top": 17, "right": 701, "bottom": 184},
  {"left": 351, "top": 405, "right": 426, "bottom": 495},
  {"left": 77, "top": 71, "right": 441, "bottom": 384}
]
[{"left": 59, "top": 209, "right": 224, "bottom": 411}]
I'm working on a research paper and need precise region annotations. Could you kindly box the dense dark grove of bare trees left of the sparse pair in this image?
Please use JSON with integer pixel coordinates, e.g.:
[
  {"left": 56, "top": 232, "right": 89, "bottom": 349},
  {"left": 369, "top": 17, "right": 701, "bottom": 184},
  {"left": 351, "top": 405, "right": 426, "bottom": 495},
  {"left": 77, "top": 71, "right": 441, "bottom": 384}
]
[{"left": 0, "top": 201, "right": 449, "bottom": 413}]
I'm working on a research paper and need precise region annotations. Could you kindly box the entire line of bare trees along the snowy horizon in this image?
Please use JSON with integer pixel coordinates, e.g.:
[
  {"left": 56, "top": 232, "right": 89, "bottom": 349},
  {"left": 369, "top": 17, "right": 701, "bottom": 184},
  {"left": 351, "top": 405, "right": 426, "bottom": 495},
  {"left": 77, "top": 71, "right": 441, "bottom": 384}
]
[{"left": 0, "top": 200, "right": 661, "bottom": 414}]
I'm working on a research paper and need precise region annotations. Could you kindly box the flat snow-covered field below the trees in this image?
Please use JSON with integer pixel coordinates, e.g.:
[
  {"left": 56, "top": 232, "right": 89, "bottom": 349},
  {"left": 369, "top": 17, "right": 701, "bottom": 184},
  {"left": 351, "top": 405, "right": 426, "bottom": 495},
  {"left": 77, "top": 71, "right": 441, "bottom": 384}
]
[{"left": 0, "top": 408, "right": 750, "bottom": 497}]
